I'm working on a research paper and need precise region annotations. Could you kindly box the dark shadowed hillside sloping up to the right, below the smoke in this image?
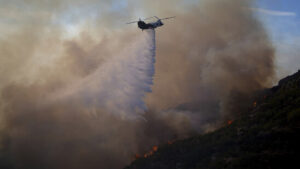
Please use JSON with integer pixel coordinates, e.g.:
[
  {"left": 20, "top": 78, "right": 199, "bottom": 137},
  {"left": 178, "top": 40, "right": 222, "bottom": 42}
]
[{"left": 125, "top": 71, "right": 300, "bottom": 169}]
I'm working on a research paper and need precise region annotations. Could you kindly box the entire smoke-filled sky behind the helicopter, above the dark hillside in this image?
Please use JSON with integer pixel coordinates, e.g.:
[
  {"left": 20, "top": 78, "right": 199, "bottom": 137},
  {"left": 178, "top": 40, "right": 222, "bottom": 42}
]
[{"left": 0, "top": 0, "right": 300, "bottom": 169}]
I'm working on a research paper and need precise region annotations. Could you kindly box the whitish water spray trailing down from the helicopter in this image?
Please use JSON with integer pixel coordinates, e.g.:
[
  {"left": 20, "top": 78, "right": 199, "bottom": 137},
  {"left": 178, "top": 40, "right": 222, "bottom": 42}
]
[{"left": 54, "top": 30, "right": 155, "bottom": 119}]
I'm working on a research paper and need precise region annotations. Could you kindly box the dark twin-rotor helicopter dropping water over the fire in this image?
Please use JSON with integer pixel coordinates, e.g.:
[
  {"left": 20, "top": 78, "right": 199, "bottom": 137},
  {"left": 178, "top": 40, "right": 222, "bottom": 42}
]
[{"left": 126, "top": 16, "right": 175, "bottom": 31}]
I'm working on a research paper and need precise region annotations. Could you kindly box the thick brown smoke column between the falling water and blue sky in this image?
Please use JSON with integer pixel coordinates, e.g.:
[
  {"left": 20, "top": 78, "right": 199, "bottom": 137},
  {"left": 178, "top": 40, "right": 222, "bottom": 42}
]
[{"left": 147, "top": 0, "right": 274, "bottom": 130}]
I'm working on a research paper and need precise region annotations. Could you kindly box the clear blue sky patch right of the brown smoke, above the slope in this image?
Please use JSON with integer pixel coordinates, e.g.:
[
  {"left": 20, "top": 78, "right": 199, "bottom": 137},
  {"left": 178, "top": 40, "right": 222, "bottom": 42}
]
[{"left": 257, "top": 0, "right": 300, "bottom": 77}]
